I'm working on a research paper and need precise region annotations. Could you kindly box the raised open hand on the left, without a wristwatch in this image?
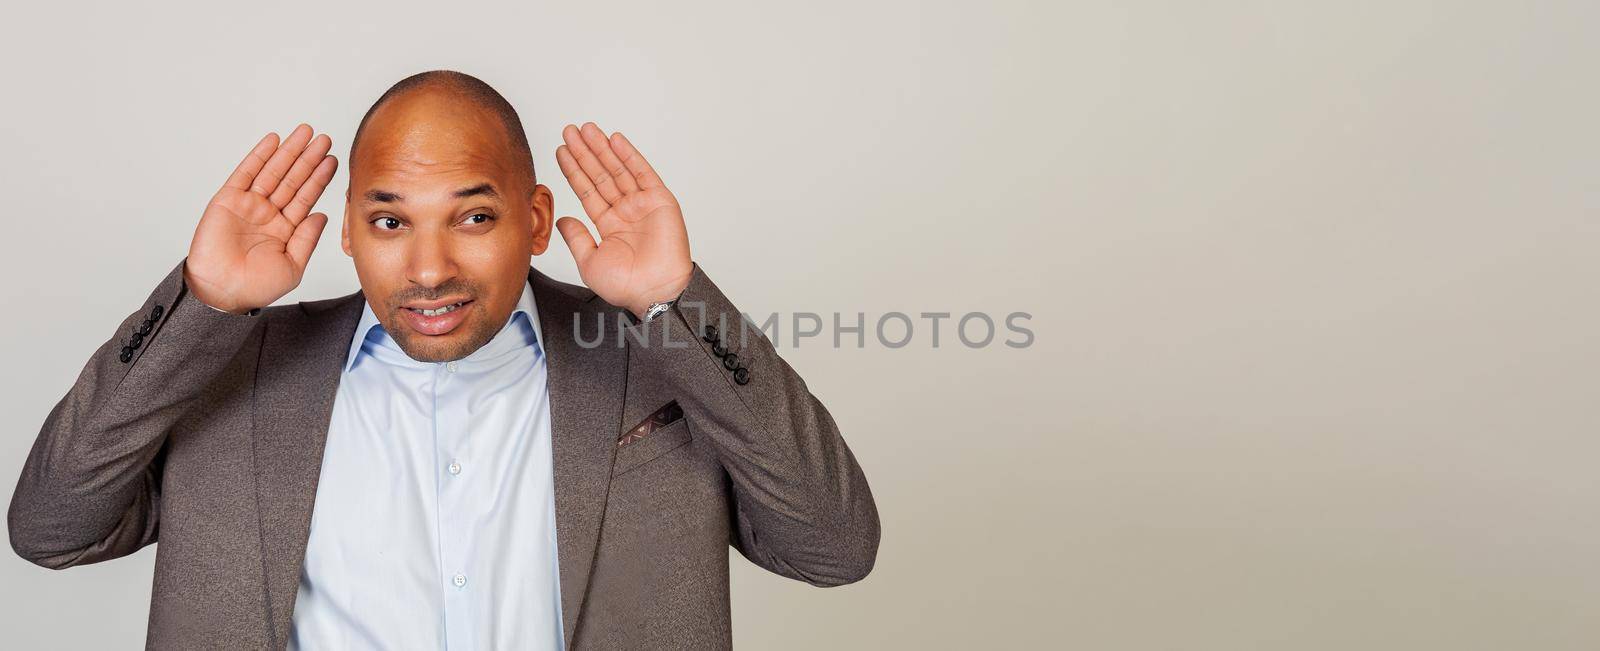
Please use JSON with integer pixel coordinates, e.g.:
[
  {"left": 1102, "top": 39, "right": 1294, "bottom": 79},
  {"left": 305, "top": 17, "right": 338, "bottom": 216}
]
[{"left": 184, "top": 125, "right": 339, "bottom": 314}]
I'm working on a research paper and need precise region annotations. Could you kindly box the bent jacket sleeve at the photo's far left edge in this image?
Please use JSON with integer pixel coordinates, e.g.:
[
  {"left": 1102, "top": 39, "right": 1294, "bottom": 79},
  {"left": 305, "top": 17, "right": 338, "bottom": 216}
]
[{"left": 6, "top": 259, "right": 261, "bottom": 569}]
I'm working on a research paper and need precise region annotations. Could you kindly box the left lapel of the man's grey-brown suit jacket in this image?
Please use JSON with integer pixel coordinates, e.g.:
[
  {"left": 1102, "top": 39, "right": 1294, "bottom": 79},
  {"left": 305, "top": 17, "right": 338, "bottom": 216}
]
[{"left": 253, "top": 291, "right": 366, "bottom": 649}]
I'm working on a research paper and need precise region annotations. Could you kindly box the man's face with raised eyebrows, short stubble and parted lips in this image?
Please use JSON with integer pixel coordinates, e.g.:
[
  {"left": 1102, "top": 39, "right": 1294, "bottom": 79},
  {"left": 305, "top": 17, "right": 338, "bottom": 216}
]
[{"left": 341, "top": 90, "right": 552, "bottom": 361}]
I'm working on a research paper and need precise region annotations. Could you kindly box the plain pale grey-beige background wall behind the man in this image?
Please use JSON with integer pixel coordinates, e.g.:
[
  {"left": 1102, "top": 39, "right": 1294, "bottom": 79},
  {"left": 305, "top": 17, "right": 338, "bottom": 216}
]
[{"left": 0, "top": 0, "right": 1600, "bottom": 649}]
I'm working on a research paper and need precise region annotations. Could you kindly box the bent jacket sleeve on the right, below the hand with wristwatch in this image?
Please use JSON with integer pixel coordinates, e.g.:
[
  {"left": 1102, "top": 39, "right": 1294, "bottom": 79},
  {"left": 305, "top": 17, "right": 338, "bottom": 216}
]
[{"left": 629, "top": 264, "right": 880, "bottom": 587}]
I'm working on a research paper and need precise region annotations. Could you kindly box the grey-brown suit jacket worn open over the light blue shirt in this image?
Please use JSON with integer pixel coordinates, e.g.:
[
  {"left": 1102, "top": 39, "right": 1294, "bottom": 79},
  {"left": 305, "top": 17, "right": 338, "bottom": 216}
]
[{"left": 6, "top": 262, "right": 878, "bottom": 649}]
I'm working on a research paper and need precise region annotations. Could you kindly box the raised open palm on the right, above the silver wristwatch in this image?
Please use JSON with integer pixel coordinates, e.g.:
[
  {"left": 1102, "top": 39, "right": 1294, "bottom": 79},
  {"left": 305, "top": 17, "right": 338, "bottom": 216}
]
[{"left": 555, "top": 122, "right": 694, "bottom": 315}]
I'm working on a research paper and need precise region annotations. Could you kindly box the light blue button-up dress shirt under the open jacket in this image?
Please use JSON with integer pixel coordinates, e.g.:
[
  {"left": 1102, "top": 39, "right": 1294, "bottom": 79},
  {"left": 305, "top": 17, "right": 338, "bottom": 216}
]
[{"left": 290, "top": 285, "right": 563, "bottom": 649}]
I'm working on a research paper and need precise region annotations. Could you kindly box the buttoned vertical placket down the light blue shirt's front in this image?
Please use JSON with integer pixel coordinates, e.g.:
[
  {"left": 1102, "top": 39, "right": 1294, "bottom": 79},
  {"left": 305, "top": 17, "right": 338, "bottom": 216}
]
[{"left": 434, "top": 361, "right": 475, "bottom": 649}]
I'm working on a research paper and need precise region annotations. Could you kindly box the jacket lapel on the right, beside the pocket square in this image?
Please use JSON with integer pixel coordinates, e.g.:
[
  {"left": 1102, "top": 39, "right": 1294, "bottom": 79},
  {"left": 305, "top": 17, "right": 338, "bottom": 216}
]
[{"left": 528, "top": 270, "right": 627, "bottom": 648}]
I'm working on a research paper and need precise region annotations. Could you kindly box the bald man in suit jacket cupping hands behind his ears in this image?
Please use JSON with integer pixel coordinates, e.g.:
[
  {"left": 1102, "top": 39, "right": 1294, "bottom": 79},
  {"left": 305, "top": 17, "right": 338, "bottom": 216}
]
[{"left": 8, "top": 70, "right": 878, "bottom": 649}]
